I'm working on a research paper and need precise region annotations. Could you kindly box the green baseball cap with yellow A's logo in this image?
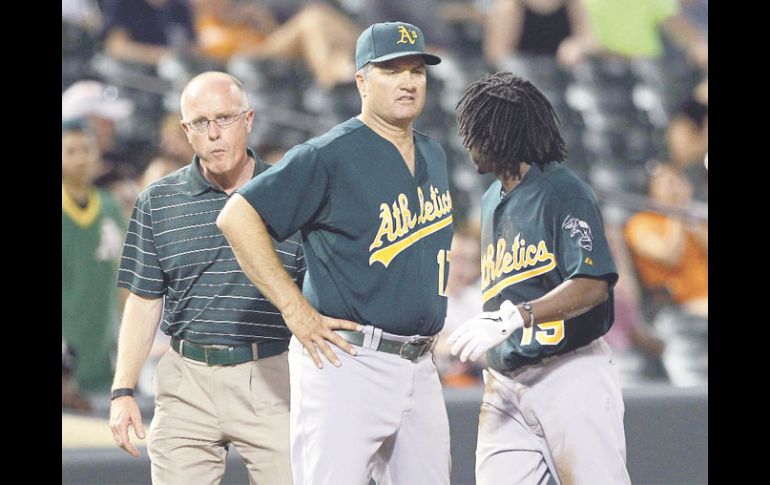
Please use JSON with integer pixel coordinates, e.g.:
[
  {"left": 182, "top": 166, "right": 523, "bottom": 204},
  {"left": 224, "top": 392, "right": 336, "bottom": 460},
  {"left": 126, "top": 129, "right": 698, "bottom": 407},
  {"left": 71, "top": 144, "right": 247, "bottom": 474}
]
[{"left": 356, "top": 22, "right": 441, "bottom": 70}]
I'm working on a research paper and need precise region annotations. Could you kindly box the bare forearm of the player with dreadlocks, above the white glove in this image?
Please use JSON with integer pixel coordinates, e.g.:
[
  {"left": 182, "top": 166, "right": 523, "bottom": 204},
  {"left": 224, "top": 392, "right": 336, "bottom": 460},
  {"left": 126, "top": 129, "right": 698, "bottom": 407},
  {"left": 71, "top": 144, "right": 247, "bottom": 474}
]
[{"left": 518, "top": 278, "right": 609, "bottom": 326}]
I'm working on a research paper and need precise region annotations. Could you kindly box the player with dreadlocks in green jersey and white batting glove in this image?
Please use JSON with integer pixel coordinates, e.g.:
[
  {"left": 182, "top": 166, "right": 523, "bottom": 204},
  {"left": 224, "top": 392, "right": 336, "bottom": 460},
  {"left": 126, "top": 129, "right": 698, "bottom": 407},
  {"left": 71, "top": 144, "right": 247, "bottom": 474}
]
[{"left": 448, "top": 72, "right": 630, "bottom": 485}]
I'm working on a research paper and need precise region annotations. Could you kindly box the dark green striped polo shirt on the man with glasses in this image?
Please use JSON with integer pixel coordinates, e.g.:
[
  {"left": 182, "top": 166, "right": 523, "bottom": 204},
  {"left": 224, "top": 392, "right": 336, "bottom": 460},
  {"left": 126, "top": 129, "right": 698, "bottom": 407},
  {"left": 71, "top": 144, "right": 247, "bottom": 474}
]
[{"left": 118, "top": 149, "right": 305, "bottom": 345}]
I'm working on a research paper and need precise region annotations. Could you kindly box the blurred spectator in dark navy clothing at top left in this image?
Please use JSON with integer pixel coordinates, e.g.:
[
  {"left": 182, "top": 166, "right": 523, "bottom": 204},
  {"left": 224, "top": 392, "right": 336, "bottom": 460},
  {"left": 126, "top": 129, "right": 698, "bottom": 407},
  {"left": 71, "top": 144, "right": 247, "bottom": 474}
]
[{"left": 102, "top": 0, "right": 196, "bottom": 65}]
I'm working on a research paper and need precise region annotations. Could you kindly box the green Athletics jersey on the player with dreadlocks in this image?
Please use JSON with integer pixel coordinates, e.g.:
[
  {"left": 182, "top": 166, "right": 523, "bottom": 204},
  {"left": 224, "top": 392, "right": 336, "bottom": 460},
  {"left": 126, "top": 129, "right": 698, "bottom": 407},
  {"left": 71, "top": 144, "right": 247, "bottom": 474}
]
[{"left": 481, "top": 163, "right": 618, "bottom": 371}]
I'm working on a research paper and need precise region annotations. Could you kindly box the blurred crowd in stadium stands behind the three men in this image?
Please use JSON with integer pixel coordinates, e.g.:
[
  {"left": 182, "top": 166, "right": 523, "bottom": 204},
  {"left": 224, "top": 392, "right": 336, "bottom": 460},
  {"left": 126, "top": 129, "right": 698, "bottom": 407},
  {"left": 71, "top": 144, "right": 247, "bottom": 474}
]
[{"left": 62, "top": 0, "right": 708, "bottom": 410}]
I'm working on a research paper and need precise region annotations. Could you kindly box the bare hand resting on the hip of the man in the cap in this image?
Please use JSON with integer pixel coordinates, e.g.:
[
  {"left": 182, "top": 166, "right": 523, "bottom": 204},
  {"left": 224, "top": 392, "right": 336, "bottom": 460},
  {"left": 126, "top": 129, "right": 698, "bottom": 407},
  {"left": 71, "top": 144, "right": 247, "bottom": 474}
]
[{"left": 284, "top": 301, "right": 363, "bottom": 369}]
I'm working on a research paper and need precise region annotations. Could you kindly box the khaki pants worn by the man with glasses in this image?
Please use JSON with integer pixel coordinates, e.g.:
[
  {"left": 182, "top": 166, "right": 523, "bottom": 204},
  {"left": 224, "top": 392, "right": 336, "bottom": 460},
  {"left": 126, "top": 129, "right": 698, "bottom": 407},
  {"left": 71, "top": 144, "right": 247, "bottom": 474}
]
[{"left": 147, "top": 349, "right": 292, "bottom": 485}]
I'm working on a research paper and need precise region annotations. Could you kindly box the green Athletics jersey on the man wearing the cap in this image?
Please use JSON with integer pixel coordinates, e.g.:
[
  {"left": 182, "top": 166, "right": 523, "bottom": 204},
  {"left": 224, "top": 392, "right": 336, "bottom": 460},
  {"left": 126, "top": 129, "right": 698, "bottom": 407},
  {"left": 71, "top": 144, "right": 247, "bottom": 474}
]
[{"left": 239, "top": 118, "right": 453, "bottom": 335}]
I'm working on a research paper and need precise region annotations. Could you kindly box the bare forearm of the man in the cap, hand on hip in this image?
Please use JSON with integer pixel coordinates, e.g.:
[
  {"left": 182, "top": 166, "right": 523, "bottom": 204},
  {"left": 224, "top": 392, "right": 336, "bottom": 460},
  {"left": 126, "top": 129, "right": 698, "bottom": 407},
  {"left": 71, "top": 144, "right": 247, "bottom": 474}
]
[{"left": 217, "top": 194, "right": 307, "bottom": 316}]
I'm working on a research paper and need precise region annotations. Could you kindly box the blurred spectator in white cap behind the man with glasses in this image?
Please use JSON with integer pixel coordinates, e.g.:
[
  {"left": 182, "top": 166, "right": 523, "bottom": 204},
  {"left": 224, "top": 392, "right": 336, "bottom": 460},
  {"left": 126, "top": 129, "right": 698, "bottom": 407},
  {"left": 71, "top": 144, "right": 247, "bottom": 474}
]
[{"left": 61, "top": 80, "right": 134, "bottom": 186}]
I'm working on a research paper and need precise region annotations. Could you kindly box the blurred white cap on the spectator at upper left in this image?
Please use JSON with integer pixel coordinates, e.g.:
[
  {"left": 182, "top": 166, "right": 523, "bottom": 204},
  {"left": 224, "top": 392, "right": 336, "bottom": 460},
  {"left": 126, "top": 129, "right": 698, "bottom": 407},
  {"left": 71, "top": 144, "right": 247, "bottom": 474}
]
[{"left": 61, "top": 81, "right": 134, "bottom": 121}]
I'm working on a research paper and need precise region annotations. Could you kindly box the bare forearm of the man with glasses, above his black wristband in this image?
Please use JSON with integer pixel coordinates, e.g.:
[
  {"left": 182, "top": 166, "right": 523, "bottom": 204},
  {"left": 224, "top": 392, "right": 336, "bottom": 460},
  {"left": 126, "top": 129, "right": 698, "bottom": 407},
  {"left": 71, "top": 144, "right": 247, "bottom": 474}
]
[{"left": 112, "top": 293, "right": 163, "bottom": 389}]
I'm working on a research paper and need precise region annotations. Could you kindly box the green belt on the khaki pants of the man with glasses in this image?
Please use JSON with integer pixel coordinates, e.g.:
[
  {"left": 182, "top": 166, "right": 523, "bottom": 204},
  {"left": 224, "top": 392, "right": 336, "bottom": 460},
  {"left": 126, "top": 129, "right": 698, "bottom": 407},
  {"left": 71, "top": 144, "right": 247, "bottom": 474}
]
[{"left": 171, "top": 337, "right": 289, "bottom": 365}]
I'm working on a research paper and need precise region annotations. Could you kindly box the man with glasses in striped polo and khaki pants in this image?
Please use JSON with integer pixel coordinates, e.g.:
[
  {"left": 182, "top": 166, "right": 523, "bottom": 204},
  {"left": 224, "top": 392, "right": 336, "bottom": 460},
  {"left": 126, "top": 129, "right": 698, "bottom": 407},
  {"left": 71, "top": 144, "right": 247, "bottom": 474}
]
[{"left": 110, "top": 72, "right": 305, "bottom": 485}]
